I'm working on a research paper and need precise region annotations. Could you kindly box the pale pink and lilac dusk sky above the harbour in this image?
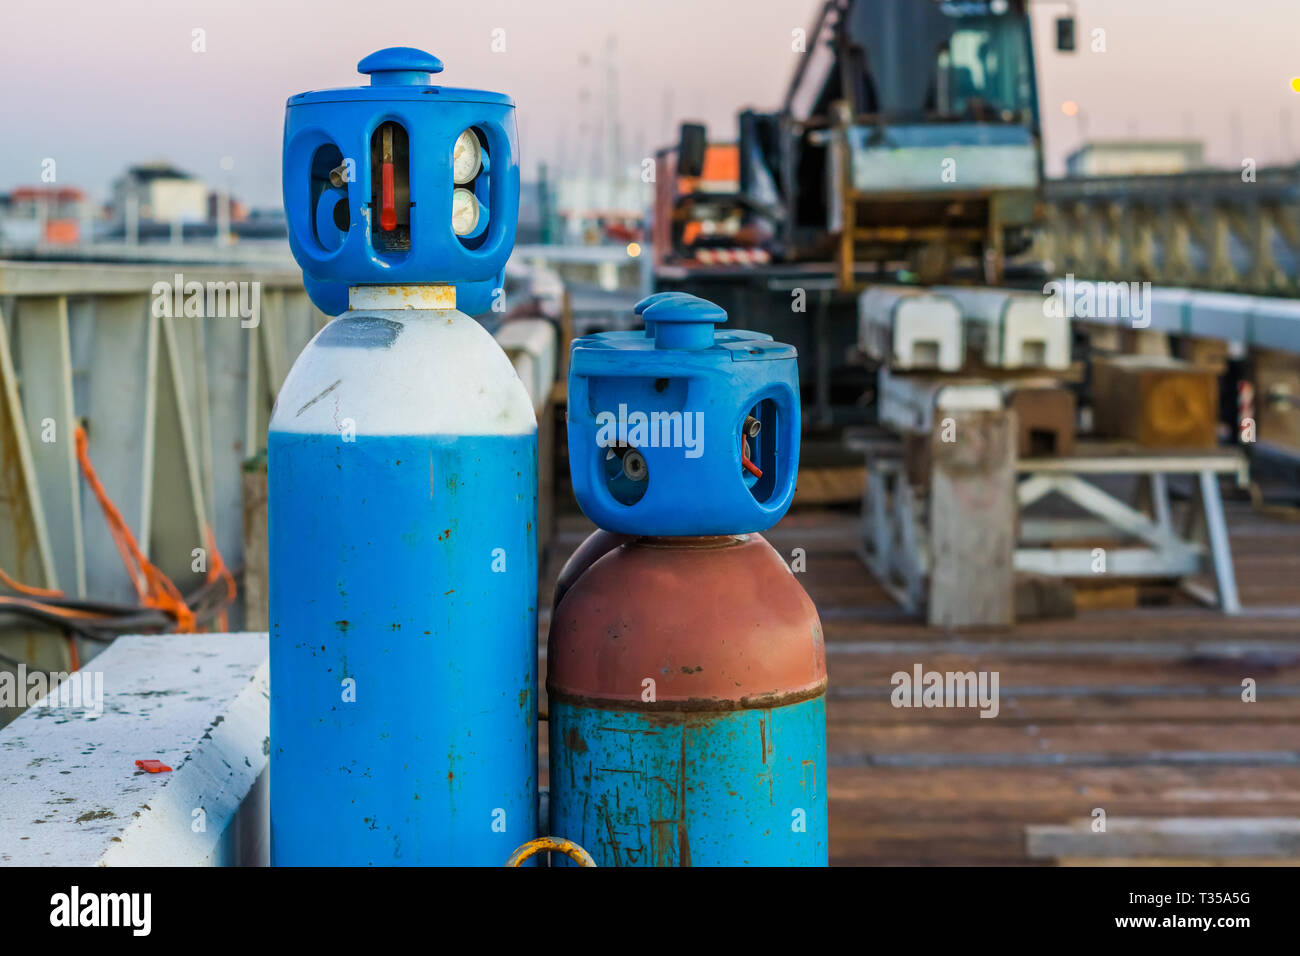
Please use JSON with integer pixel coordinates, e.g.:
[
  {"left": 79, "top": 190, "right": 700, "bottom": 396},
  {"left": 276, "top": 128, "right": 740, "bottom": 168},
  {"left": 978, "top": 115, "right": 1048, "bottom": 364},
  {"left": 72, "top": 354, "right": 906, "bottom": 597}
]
[{"left": 0, "top": 0, "right": 1300, "bottom": 206}]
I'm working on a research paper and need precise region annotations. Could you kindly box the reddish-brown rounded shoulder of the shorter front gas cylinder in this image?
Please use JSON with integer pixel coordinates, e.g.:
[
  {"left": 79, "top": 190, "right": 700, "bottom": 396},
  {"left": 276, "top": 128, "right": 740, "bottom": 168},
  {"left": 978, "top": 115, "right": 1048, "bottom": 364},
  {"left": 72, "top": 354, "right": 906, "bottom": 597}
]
[{"left": 546, "top": 535, "right": 826, "bottom": 709}]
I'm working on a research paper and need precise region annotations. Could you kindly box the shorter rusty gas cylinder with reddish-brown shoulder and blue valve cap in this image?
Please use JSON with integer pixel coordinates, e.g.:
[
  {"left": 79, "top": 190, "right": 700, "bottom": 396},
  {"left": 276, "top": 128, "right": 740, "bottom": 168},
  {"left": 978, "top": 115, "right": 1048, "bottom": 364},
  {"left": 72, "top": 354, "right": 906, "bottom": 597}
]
[{"left": 546, "top": 293, "right": 827, "bottom": 866}]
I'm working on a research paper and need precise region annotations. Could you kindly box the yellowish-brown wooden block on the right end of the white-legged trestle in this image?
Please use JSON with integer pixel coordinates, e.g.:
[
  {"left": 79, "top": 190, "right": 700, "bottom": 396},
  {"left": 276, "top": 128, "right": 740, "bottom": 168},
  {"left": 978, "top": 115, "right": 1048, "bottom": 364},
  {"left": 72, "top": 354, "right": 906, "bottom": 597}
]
[{"left": 1092, "top": 355, "right": 1218, "bottom": 449}]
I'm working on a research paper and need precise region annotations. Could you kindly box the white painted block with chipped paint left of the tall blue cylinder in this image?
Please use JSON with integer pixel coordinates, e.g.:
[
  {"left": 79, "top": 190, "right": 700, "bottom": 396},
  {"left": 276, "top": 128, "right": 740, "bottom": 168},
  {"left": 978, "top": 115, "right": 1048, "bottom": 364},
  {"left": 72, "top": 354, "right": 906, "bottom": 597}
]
[{"left": 0, "top": 633, "right": 270, "bottom": 866}]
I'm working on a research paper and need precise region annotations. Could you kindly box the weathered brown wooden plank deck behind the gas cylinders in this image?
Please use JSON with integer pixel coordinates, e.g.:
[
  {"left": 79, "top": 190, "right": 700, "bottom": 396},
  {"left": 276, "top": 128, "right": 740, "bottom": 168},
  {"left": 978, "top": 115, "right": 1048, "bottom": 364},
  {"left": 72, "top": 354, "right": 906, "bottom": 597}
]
[{"left": 542, "top": 501, "right": 1300, "bottom": 865}]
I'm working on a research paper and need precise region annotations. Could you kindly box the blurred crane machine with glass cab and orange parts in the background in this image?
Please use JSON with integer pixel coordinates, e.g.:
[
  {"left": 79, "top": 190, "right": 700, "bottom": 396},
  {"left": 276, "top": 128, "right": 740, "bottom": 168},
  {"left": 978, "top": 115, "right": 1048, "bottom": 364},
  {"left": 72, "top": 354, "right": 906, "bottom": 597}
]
[{"left": 654, "top": 0, "right": 1073, "bottom": 291}]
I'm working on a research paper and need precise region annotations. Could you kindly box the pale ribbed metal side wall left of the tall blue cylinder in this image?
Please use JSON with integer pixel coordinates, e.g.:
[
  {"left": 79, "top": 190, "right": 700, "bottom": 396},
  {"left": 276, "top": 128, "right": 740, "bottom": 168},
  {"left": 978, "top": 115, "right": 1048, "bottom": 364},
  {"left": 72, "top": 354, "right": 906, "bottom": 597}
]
[{"left": 0, "top": 261, "right": 328, "bottom": 666}]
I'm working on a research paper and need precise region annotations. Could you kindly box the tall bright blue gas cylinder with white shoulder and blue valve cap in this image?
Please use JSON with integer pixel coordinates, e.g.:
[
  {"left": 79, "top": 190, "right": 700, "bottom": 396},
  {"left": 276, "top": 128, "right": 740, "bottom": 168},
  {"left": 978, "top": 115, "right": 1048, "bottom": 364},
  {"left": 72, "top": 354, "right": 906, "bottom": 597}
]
[{"left": 268, "top": 47, "right": 537, "bottom": 865}]
